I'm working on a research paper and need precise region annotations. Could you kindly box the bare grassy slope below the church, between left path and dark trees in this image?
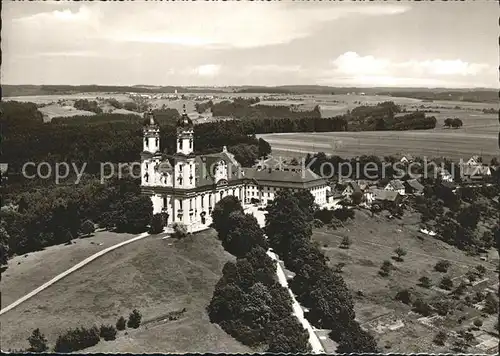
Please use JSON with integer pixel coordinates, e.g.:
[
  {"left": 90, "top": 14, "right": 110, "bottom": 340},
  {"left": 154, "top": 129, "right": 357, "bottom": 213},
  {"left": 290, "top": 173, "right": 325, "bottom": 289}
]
[{"left": 0, "top": 230, "right": 252, "bottom": 353}]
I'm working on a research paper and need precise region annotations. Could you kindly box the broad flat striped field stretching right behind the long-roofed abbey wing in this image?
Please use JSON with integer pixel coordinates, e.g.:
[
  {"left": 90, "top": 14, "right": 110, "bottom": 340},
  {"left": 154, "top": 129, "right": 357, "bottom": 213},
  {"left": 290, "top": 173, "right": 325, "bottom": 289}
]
[{"left": 257, "top": 124, "right": 498, "bottom": 160}]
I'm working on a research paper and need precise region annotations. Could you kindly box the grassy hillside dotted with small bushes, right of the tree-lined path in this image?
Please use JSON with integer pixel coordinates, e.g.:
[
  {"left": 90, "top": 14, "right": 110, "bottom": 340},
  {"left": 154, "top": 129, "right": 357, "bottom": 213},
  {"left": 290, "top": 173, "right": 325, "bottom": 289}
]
[{"left": 313, "top": 211, "right": 498, "bottom": 353}]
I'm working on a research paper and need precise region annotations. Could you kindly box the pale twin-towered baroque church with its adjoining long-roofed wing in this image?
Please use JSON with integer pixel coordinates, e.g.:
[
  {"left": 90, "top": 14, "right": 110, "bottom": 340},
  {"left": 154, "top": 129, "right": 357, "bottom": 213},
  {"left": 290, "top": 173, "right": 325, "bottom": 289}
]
[{"left": 141, "top": 109, "right": 328, "bottom": 232}]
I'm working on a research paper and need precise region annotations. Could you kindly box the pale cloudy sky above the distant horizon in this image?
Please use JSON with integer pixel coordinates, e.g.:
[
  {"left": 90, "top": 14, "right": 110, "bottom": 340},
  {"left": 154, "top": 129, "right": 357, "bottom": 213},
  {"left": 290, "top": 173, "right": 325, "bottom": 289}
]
[{"left": 1, "top": 0, "right": 499, "bottom": 88}]
